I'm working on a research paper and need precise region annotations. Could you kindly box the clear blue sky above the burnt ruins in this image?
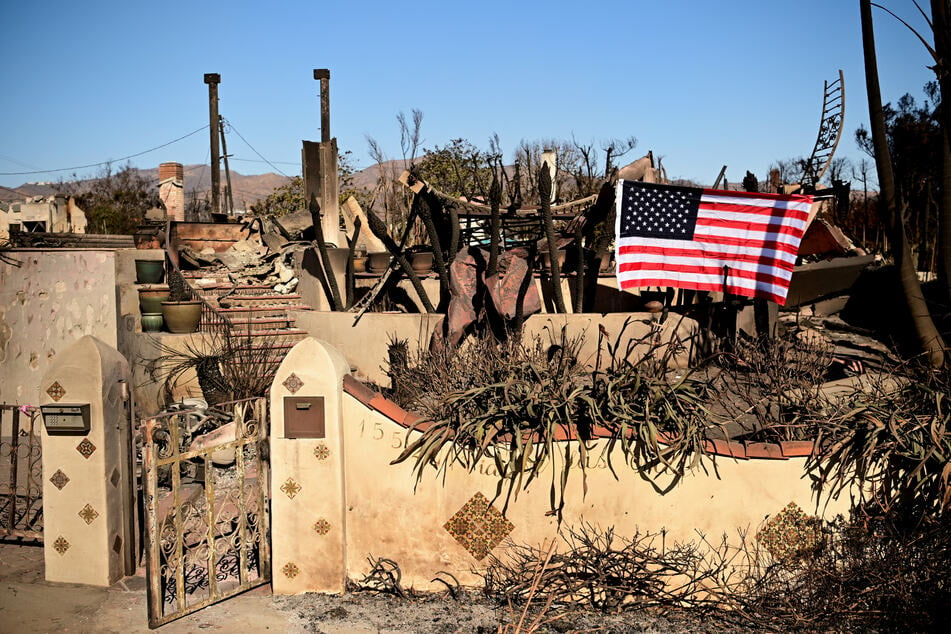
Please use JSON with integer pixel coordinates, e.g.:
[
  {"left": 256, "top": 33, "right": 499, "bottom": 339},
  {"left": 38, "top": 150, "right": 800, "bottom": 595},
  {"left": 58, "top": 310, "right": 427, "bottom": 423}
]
[{"left": 0, "top": 0, "right": 934, "bottom": 193}]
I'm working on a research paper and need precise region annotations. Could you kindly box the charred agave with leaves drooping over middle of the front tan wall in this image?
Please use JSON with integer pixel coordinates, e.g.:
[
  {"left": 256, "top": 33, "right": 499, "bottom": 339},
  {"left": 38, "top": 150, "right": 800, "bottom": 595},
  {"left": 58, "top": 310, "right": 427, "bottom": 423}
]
[{"left": 389, "top": 320, "right": 707, "bottom": 517}]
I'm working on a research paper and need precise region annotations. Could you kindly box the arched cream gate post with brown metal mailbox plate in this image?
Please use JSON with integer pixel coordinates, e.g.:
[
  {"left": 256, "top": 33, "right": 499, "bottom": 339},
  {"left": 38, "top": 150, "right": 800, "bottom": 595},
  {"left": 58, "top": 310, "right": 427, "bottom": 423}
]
[{"left": 270, "top": 337, "right": 350, "bottom": 594}]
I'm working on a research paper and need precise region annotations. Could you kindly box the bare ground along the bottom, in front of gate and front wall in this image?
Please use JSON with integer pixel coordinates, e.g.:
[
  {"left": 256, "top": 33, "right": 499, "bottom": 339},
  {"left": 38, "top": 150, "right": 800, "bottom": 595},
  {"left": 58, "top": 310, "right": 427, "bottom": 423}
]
[{"left": 0, "top": 542, "right": 740, "bottom": 634}]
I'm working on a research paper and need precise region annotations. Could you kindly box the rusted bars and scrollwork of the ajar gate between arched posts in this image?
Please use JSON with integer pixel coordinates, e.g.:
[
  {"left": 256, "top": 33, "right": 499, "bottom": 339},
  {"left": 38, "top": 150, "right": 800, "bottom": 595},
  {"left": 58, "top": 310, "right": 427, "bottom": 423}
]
[{"left": 143, "top": 397, "right": 271, "bottom": 628}]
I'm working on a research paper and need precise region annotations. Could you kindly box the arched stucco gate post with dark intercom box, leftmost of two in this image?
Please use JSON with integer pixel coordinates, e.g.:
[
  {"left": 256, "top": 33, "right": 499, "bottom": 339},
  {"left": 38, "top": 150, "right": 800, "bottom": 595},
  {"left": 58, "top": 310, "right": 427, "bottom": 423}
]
[{"left": 38, "top": 335, "right": 134, "bottom": 586}]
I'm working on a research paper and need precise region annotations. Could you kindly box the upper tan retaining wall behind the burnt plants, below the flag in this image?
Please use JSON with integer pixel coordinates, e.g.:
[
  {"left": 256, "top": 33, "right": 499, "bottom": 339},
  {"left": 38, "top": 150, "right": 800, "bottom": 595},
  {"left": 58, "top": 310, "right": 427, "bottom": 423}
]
[{"left": 293, "top": 311, "right": 697, "bottom": 386}]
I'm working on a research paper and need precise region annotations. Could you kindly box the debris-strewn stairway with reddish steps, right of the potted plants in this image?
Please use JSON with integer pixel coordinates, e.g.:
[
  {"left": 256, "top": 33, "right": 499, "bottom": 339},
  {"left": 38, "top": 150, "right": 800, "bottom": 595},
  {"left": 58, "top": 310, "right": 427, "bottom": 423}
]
[{"left": 184, "top": 271, "right": 311, "bottom": 376}]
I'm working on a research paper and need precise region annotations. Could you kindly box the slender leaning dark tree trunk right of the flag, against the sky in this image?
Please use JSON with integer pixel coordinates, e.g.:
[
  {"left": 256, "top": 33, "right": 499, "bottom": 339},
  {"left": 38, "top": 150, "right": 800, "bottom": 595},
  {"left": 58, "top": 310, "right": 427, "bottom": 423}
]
[{"left": 859, "top": 0, "right": 944, "bottom": 367}]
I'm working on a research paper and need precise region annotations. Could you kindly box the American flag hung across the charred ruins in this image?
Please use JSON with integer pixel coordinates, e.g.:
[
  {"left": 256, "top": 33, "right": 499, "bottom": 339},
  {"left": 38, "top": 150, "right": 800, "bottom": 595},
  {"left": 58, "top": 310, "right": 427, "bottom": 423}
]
[{"left": 615, "top": 180, "right": 812, "bottom": 305}]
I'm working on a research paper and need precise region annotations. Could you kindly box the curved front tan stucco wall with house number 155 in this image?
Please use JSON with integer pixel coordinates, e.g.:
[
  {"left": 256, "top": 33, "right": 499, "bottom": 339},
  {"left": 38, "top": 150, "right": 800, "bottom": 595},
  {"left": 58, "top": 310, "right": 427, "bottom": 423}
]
[{"left": 342, "top": 395, "right": 847, "bottom": 589}]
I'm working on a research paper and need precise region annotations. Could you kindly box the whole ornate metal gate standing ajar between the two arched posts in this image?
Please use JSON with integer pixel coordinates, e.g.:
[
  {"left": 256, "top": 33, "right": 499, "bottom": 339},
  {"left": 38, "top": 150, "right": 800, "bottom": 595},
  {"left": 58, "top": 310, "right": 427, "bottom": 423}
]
[{"left": 143, "top": 398, "right": 271, "bottom": 628}]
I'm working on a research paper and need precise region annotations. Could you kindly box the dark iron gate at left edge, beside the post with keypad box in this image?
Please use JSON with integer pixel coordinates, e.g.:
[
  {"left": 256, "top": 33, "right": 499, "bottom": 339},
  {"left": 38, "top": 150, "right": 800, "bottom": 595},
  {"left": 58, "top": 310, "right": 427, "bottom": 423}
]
[{"left": 0, "top": 404, "right": 43, "bottom": 541}]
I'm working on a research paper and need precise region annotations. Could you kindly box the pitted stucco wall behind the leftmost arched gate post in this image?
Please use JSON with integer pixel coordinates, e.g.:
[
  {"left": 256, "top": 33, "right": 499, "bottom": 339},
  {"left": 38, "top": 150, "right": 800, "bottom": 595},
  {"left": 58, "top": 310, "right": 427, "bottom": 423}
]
[{"left": 0, "top": 249, "right": 117, "bottom": 404}]
